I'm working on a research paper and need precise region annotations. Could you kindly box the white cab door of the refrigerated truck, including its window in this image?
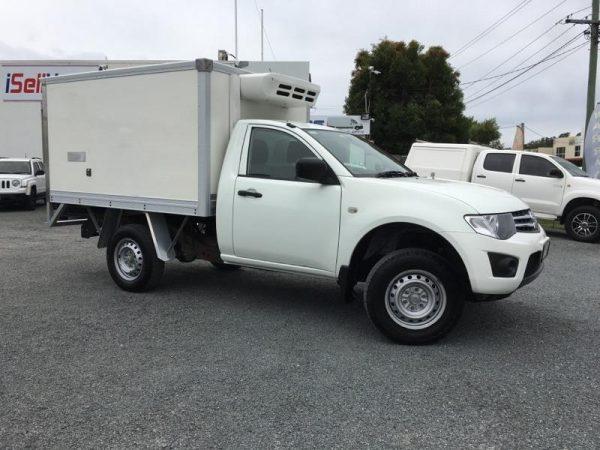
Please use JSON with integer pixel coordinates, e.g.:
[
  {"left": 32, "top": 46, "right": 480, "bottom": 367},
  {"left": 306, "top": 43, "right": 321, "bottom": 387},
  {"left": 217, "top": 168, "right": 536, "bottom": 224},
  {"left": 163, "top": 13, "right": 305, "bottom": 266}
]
[{"left": 233, "top": 126, "right": 341, "bottom": 273}]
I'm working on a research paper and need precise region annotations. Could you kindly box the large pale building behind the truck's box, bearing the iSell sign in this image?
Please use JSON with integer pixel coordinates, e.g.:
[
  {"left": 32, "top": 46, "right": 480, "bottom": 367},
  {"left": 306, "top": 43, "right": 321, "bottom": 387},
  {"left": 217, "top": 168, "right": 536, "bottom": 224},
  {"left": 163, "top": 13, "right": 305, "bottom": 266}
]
[{"left": 0, "top": 60, "right": 310, "bottom": 158}]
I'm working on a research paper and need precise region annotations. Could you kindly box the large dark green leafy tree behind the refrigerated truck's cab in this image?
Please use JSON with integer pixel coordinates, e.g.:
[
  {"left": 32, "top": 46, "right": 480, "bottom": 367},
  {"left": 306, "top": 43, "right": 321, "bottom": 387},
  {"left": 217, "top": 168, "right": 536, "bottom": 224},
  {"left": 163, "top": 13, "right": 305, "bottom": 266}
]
[{"left": 344, "top": 39, "right": 470, "bottom": 154}]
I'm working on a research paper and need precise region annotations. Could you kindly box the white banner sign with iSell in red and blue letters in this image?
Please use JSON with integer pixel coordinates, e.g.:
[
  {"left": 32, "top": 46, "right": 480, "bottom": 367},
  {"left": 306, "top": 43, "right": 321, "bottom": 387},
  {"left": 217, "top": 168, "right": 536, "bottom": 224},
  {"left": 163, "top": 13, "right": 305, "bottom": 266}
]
[{"left": 0, "top": 65, "right": 98, "bottom": 101}]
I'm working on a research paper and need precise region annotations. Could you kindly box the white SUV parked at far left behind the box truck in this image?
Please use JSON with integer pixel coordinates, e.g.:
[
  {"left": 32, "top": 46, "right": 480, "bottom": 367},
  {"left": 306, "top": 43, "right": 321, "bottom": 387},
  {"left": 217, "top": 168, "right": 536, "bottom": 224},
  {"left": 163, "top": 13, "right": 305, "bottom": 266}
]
[{"left": 0, "top": 158, "right": 46, "bottom": 209}]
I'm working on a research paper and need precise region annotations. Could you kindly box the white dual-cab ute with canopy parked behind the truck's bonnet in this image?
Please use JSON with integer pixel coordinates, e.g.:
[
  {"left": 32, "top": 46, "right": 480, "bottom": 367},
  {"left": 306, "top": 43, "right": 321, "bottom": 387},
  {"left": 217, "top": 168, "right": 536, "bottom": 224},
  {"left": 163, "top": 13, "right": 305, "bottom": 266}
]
[{"left": 405, "top": 142, "right": 600, "bottom": 242}]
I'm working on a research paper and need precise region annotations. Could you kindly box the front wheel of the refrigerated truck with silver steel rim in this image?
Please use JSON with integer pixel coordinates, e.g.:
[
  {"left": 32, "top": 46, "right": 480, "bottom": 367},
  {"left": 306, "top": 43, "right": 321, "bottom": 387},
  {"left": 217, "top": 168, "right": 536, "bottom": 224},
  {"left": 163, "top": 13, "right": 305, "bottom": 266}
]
[{"left": 364, "top": 248, "right": 466, "bottom": 344}]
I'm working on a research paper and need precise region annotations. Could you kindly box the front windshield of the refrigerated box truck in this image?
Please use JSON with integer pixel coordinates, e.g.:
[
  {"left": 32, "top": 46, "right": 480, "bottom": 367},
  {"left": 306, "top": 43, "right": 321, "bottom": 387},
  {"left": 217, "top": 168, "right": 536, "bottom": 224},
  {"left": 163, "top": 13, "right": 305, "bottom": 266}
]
[{"left": 304, "top": 128, "right": 416, "bottom": 177}]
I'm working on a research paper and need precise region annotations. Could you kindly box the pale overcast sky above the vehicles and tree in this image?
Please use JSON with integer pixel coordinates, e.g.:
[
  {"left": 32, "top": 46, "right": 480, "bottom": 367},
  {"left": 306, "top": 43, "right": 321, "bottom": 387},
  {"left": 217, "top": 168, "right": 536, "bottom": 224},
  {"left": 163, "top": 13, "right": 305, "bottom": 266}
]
[{"left": 0, "top": 0, "right": 600, "bottom": 146}]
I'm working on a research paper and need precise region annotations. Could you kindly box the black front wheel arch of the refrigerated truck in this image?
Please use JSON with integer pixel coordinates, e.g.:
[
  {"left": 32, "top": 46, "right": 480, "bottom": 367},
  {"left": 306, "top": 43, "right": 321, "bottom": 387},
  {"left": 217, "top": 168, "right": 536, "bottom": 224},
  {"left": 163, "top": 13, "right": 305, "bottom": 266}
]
[{"left": 344, "top": 222, "right": 471, "bottom": 290}]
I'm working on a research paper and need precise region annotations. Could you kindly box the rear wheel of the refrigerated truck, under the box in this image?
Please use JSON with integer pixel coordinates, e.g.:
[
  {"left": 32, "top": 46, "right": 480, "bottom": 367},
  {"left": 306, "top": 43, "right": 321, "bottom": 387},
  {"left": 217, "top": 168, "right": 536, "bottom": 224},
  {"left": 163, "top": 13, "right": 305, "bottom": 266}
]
[{"left": 106, "top": 224, "right": 165, "bottom": 292}]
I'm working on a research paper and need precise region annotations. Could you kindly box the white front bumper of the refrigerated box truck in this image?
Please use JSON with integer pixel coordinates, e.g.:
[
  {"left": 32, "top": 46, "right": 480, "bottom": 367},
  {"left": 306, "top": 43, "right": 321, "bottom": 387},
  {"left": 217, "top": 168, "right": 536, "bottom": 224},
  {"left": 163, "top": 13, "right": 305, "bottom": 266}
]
[{"left": 445, "top": 228, "right": 550, "bottom": 296}]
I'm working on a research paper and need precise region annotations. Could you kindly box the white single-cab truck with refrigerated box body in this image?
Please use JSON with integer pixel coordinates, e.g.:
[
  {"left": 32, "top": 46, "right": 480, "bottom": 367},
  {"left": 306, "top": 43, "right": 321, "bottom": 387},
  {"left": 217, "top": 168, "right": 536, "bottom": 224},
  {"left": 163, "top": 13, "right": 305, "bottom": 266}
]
[{"left": 42, "top": 59, "right": 549, "bottom": 343}]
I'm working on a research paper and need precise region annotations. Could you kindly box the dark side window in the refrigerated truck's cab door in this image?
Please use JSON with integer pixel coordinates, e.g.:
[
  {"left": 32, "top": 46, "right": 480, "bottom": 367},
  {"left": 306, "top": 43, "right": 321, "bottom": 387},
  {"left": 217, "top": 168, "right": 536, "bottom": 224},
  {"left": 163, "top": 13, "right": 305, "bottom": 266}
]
[{"left": 247, "top": 128, "right": 316, "bottom": 181}]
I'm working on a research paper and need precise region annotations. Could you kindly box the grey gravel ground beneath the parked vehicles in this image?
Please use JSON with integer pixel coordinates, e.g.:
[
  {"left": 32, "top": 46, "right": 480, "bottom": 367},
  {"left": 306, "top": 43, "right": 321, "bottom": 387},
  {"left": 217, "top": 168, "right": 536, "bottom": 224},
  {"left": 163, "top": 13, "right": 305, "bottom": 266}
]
[{"left": 0, "top": 207, "right": 600, "bottom": 448}]
